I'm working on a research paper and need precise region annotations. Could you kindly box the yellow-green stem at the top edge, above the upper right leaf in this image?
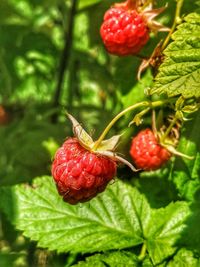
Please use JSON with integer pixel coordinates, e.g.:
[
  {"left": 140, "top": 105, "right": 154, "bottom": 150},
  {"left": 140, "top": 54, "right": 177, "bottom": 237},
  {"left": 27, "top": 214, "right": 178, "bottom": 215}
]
[{"left": 161, "top": 0, "right": 184, "bottom": 51}]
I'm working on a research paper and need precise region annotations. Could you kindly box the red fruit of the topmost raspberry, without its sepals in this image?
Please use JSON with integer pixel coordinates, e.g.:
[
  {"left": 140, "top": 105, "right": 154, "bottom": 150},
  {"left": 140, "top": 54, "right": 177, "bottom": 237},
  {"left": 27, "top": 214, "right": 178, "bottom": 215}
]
[{"left": 100, "top": 6, "right": 149, "bottom": 56}]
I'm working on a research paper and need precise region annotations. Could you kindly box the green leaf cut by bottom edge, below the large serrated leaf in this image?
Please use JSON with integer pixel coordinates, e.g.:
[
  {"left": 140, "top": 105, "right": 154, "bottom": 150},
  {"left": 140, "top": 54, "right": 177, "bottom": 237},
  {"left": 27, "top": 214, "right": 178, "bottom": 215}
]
[{"left": 73, "top": 251, "right": 140, "bottom": 267}]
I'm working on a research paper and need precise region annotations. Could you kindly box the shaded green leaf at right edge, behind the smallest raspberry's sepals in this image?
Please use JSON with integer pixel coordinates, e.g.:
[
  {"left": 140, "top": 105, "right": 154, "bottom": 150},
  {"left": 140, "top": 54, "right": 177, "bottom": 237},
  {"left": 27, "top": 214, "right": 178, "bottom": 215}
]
[{"left": 170, "top": 112, "right": 200, "bottom": 200}]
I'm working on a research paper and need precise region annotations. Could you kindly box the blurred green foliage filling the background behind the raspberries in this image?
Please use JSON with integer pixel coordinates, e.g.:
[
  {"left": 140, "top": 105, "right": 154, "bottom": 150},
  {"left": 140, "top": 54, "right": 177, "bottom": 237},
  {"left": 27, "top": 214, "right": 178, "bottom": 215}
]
[{"left": 0, "top": 0, "right": 199, "bottom": 267}]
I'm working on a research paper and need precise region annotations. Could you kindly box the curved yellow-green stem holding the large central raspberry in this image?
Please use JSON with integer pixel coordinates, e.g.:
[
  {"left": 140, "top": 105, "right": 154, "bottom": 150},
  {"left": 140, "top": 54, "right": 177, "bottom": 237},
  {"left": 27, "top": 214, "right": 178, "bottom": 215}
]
[{"left": 93, "top": 98, "right": 175, "bottom": 151}]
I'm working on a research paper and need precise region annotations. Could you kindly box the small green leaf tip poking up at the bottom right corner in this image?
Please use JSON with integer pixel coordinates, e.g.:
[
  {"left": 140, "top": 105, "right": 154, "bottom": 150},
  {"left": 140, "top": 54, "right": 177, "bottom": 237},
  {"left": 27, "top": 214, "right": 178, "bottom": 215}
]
[{"left": 167, "top": 248, "right": 200, "bottom": 267}]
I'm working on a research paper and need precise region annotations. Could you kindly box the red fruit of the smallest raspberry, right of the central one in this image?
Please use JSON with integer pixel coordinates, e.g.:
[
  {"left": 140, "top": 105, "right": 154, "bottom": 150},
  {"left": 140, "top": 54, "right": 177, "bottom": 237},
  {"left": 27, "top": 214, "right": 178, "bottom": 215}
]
[{"left": 130, "top": 129, "right": 171, "bottom": 170}]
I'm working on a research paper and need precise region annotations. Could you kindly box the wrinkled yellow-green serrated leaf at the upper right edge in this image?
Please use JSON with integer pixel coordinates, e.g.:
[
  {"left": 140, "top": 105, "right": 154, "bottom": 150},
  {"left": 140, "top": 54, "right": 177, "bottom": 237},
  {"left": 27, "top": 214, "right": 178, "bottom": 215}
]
[{"left": 150, "top": 13, "right": 200, "bottom": 98}]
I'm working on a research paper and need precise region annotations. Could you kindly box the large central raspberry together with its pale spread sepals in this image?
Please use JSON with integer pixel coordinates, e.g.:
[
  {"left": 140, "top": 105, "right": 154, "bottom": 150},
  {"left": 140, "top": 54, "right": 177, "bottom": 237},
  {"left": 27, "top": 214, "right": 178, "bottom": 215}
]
[{"left": 51, "top": 114, "right": 135, "bottom": 204}]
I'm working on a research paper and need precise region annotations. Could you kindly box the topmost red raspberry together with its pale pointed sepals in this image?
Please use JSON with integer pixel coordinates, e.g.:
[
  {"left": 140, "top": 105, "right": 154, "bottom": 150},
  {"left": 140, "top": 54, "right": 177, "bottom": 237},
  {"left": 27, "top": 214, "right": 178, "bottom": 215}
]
[{"left": 100, "top": 0, "right": 168, "bottom": 56}]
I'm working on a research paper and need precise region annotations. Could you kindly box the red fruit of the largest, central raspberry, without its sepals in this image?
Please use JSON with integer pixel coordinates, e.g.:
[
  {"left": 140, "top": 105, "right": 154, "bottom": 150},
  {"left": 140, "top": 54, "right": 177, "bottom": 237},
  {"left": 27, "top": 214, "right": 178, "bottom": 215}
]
[{"left": 52, "top": 138, "right": 116, "bottom": 204}]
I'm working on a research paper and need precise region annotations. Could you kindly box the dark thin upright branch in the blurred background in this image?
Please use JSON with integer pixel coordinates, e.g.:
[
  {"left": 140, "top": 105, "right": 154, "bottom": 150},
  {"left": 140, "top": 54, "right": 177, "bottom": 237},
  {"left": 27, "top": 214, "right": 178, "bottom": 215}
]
[{"left": 52, "top": 0, "right": 78, "bottom": 122}]
